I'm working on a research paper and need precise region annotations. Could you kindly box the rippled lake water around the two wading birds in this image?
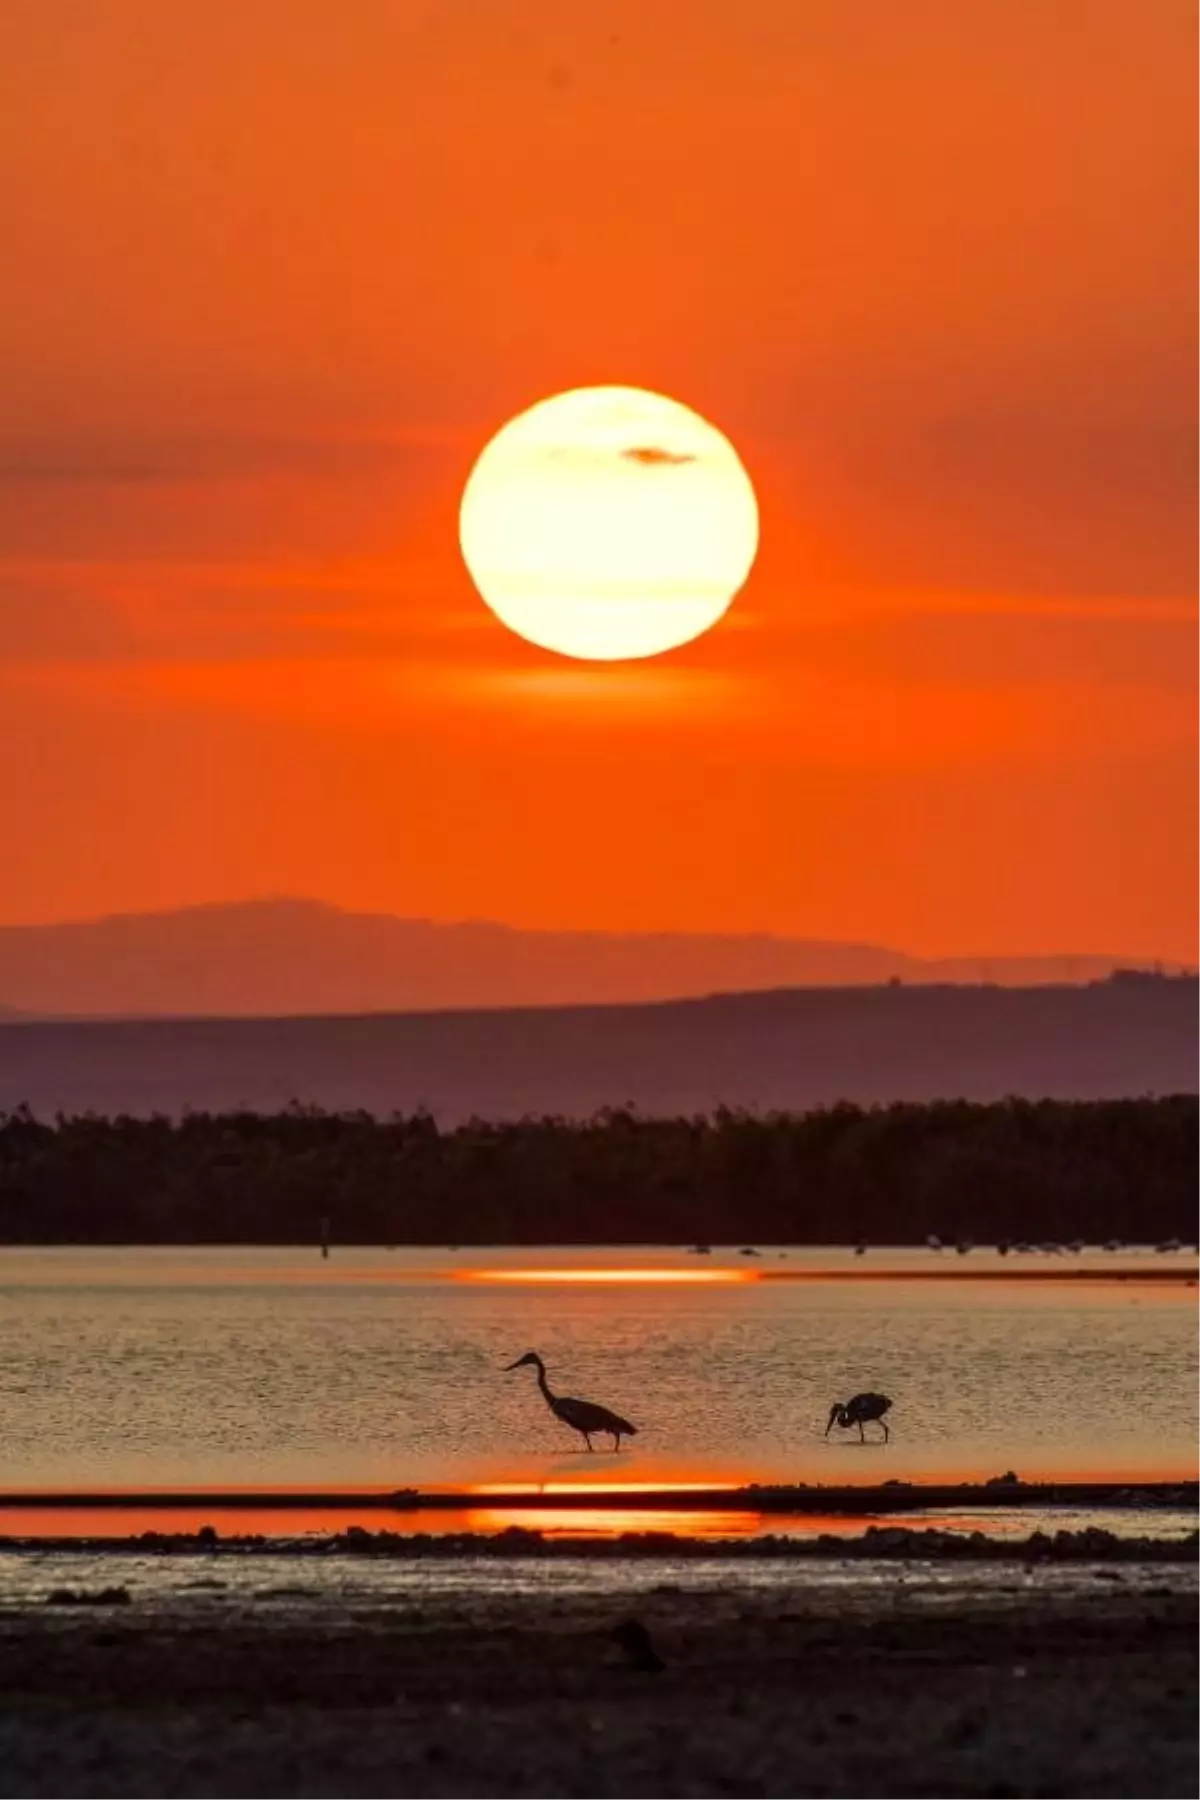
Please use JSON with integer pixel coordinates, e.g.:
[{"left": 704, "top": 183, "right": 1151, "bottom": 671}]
[{"left": 0, "top": 1249, "right": 1200, "bottom": 1490}]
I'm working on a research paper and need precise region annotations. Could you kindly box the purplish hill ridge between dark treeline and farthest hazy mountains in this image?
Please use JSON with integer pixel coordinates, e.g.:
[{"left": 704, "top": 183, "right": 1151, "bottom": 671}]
[{"left": 0, "top": 976, "right": 1200, "bottom": 1123}]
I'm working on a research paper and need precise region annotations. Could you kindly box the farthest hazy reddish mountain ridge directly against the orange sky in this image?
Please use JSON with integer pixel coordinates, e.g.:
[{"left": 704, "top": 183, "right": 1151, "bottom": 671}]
[{"left": 0, "top": 900, "right": 1187, "bottom": 1017}]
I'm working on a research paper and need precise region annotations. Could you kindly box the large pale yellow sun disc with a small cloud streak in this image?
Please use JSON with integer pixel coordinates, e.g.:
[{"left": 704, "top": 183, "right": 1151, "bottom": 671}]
[{"left": 459, "top": 387, "right": 759, "bottom": 662}]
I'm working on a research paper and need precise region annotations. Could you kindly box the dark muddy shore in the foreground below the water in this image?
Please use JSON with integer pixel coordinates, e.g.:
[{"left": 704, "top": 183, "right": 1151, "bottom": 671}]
[{"left": 0, "top": 1555, "right": 1200, "bottom": 1800}]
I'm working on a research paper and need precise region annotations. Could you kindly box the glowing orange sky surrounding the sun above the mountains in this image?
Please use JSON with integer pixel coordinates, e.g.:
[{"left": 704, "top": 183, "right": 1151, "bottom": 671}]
[{"left": 0, "top": 0, "right": 1200, "bottom": 958}]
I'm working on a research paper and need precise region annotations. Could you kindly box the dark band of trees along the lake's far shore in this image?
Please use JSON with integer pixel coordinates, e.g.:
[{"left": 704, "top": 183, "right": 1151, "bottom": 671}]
[{"left": 0, "top": 1096, "right": 1200, "bottom": 1244}]
